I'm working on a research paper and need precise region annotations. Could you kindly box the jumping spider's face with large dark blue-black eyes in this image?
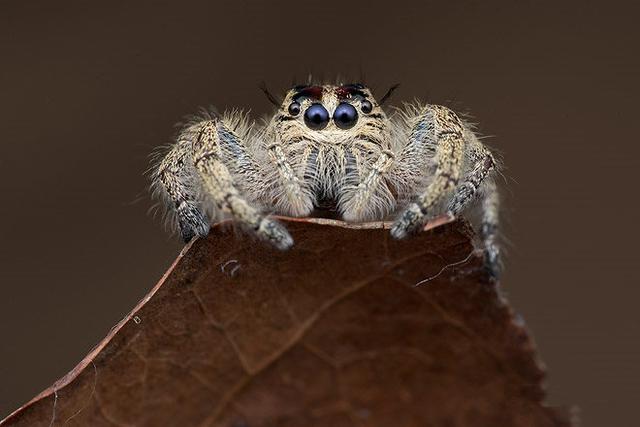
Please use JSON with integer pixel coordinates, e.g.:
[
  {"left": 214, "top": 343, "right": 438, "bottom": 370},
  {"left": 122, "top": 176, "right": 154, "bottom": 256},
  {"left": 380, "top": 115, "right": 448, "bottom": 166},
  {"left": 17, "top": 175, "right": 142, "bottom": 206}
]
[{"left": 276, "top": 83, "right": 386, "bottom": 143}]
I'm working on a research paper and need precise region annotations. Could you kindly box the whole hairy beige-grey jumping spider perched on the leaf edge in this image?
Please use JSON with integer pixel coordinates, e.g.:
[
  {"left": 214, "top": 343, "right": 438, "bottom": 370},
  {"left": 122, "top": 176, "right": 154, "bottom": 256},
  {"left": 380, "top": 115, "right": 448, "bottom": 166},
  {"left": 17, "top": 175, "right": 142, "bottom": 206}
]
[{"left": 152, "top": 83, "right": 500, "bottom": 277}]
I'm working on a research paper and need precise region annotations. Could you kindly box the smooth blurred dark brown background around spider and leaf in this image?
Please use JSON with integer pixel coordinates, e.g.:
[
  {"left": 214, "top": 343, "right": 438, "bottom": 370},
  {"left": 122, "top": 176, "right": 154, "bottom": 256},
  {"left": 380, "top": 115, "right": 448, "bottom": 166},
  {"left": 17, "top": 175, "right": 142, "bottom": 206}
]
[{"left": 0, "top": 0, "right": 640, "bottom": 426}]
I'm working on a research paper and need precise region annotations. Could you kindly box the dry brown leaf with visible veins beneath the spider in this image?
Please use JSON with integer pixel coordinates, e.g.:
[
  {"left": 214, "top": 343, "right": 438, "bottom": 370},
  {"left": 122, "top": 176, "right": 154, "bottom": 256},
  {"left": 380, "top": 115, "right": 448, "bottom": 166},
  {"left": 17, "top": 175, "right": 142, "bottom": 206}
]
[{"left": 2, "top": 219, "right": 570, "bottom": 427}]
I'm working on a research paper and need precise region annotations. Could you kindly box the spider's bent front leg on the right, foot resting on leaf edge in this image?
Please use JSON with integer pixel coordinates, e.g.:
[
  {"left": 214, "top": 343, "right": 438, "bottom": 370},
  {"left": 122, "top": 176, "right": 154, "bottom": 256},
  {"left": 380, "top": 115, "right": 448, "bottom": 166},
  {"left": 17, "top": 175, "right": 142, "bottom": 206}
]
[{"left": 391, "top": 105, "right": 465, "bottom": 239}]
